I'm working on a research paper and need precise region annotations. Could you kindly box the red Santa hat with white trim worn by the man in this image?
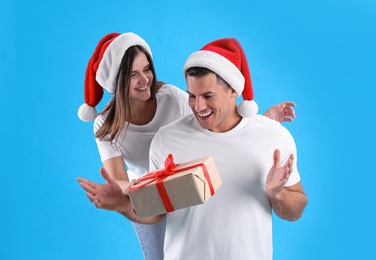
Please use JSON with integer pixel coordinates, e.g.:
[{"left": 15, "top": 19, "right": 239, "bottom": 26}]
[{"left": 183, "top": 38, "right": 258, "bottom": 117}]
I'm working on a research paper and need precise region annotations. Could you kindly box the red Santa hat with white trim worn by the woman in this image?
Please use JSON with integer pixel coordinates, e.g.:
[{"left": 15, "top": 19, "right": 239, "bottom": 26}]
[{"left": 78, "top": 32, "right": 152, "bottom": 122}]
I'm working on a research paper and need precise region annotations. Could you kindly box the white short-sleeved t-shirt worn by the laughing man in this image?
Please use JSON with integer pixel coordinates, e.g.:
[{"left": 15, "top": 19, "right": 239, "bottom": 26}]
[{"left": 150, "top": 115, "right": 300, "bottom": 260}]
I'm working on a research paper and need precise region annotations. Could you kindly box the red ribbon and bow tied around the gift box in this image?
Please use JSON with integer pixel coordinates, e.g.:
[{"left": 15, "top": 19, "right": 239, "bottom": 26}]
[{"left": 129, "top": 154, "right": 214, "bottom": 212}]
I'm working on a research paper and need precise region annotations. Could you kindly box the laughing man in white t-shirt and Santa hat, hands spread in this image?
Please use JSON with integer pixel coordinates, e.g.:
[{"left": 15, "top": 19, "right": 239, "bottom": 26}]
[{"left": 78, "top": 38, "right": 307, "bottom": 260}]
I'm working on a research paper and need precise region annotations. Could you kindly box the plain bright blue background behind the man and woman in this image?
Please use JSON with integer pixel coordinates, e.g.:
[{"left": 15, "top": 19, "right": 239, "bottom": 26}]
[{"left": 0, "top": 0, "right": 376, "bottom": 260}]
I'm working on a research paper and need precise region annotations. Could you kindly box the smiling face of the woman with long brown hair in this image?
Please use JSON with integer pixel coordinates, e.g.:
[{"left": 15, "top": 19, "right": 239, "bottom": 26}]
[{"left": 129, "top": 51, "right": 154, "bottom": 101}]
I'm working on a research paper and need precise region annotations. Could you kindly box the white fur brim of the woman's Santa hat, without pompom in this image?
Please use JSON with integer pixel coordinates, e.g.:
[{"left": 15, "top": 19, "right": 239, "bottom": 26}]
[{"left": 96, "top": 33, "right": 152, "bottom": 94}]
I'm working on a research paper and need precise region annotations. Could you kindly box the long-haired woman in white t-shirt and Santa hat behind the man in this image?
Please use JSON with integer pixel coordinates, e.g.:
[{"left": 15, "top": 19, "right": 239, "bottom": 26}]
[{"left": 78, "top": 33, "right": 295, "bottom": 259}]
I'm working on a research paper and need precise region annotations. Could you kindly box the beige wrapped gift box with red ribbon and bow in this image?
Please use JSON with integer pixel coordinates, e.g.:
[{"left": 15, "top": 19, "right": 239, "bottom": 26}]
[{"left": 129, "top": 154, "right": 222, "bottom": 218}]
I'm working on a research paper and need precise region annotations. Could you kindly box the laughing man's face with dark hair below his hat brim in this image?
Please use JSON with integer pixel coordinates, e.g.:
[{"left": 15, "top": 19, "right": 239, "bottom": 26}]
[{"left": 187, "top": 73, "right": 241, "bottom": 132}]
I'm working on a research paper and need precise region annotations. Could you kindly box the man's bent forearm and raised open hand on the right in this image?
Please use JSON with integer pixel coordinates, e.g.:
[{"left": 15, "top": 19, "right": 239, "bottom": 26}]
[{"left": 266, "top": 149, "right": 308, "bottom": 221}]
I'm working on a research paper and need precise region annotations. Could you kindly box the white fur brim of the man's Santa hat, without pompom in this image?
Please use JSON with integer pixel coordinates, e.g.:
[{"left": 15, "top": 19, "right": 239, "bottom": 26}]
[{"left": 183, "top": 50, "right": 244, "bottom": 97}]
